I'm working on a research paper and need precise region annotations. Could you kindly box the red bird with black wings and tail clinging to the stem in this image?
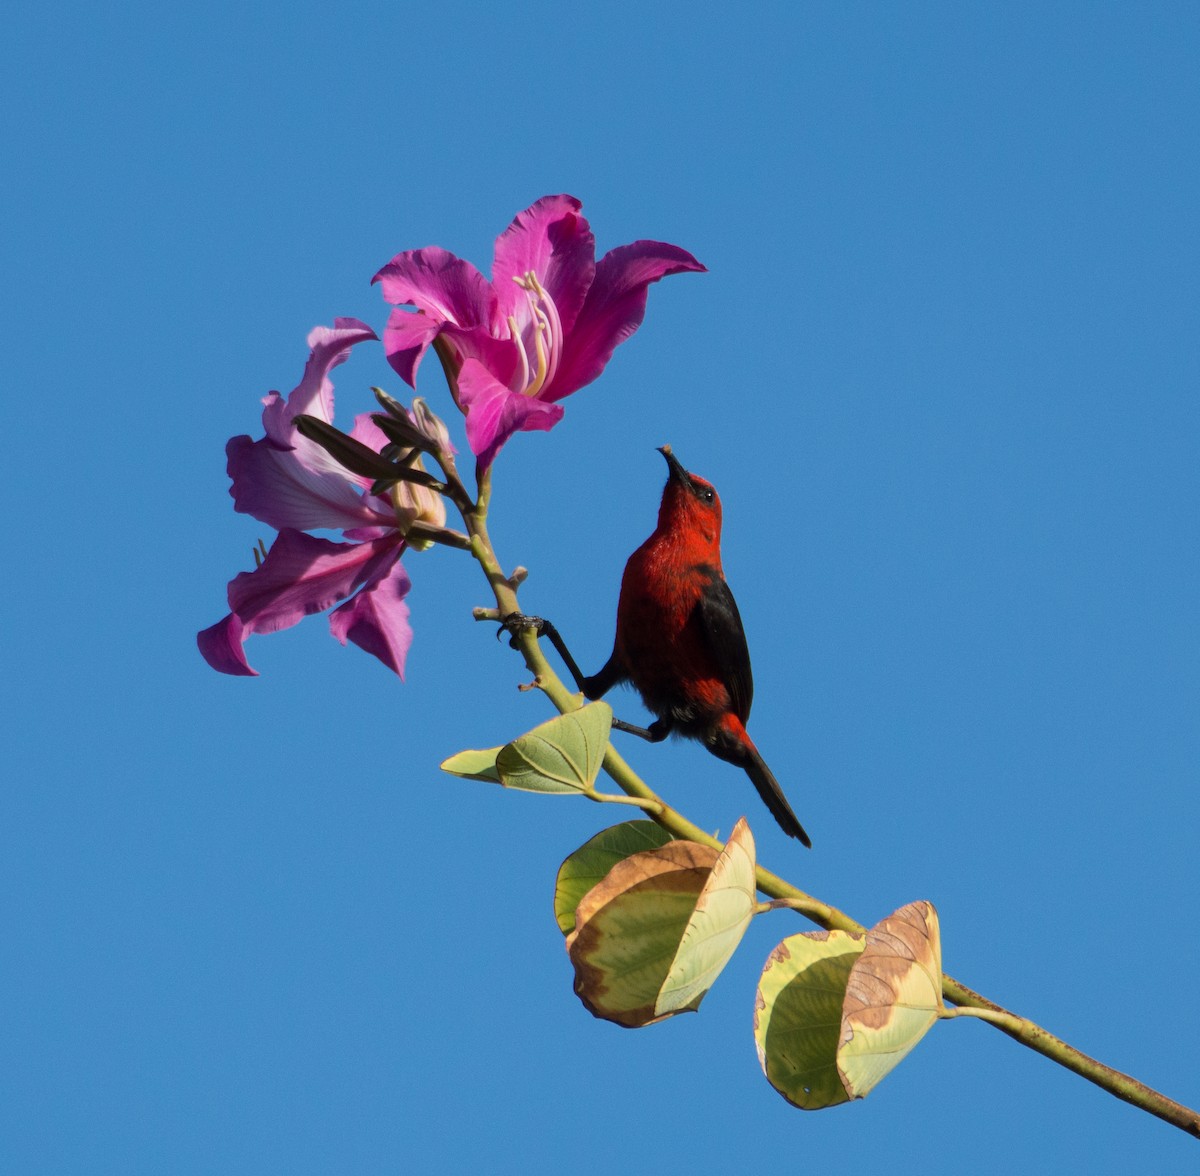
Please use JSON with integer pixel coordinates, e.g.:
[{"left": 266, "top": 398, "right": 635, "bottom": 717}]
[{"left": 505, "top": 445, "right": 812, "bottom": 847}]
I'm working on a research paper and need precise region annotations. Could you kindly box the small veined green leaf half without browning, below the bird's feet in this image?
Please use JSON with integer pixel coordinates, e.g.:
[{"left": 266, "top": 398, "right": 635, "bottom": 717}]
[{"left": 496, "top": 702, "right": 612, "bottom": 793}]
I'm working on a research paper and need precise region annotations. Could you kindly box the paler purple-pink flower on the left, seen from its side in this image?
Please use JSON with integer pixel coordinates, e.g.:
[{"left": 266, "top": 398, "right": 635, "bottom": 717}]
[{"left": 197, "top": 318, "right": 445, "bottom": 677}]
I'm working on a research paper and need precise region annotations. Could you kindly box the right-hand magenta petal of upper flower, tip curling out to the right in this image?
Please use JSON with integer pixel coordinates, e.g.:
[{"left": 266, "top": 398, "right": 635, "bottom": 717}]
[{"left": 541, "top": 241, "right": 707, "bottom": 401}]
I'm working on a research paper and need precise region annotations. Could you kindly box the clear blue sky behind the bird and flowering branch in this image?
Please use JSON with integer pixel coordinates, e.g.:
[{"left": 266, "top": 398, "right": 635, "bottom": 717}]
[{"left": 0, "top": 0, "right": 1200, "bottom": 1174}]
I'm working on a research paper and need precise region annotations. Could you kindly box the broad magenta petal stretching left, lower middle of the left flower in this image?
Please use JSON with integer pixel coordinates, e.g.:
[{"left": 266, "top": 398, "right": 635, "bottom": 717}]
[{"left": 229, "top": 529, "right": 401, "bottom": 634}]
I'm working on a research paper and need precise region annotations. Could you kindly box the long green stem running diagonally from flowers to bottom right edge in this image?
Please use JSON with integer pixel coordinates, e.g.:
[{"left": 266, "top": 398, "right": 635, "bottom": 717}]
[{"left": 439, "top": 352, "right": 1200, "bottom": 1139}]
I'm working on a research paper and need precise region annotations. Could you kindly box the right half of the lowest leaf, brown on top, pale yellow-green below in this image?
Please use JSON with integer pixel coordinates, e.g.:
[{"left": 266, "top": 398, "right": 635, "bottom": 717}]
[{"left": 838, "top": 902, "right": 942, "bottom": 1098}]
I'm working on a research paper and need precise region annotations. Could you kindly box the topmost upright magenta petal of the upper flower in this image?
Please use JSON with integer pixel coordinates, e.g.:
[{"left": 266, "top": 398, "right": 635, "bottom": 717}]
[{"left": 492, "top": 196, "right": 596, "bottom": 331}]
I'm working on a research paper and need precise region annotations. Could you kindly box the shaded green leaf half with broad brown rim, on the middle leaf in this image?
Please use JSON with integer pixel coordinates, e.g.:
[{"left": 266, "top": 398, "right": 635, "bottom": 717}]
[{"left": 566, "top": 841, "right": 718, "bottom": 1028}]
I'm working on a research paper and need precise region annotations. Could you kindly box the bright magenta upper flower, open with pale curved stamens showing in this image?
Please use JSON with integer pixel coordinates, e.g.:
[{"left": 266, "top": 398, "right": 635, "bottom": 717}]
[{"left": 374, "top": 196, "right": 704, "bottom": 468}]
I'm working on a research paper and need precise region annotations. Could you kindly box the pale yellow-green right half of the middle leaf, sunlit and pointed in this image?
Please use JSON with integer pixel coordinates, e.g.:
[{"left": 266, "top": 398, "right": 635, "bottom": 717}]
[{"left": 654, "top": 817, "right": 758, "bottom": 1014}]
